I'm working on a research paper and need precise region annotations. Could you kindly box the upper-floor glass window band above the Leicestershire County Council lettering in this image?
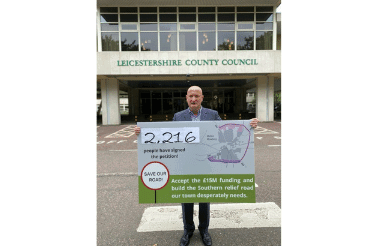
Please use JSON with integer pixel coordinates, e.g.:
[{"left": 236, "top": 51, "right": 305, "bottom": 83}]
[{"left": 99, "top": 6, "right": 274, "bottom": 51}]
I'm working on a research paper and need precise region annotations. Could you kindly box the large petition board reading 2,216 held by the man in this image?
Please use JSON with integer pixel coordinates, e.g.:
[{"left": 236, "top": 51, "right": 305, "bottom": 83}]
[{"left": 137, "top": 120, "right": 256, "bottom": 203}]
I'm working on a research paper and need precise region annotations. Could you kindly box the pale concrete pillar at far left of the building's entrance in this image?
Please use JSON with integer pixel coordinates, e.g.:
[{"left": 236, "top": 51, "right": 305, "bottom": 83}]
[{"left": 101, "top": 79, "right": 121, "bottom": 125}]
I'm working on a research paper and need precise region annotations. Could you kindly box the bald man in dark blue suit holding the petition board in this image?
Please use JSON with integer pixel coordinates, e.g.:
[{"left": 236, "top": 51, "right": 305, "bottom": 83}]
[{"left": 134, "top": 86, "right": 259, "bottom": 246}]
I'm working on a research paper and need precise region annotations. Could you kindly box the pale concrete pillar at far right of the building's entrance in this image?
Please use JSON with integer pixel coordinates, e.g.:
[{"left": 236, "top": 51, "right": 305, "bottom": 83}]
[{"left": 256, "top": 76, "right": 274, "bottom": 122}]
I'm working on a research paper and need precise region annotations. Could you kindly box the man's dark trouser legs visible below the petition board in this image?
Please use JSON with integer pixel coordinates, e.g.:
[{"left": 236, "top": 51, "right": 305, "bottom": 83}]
[{"left": 181, "top": 203, "right": 210, "bottom": 232}]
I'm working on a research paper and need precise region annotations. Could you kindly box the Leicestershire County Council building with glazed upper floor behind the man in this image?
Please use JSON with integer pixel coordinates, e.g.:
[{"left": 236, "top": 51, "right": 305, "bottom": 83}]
[{"left": 97, "top": 0, "right": 281, "bottom": 125}]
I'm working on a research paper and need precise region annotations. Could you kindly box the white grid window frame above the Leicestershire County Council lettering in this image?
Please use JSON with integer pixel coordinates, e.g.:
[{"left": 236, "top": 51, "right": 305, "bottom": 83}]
[{"left": 97, "top": 5, "right": 276, "bottom": 52}]
